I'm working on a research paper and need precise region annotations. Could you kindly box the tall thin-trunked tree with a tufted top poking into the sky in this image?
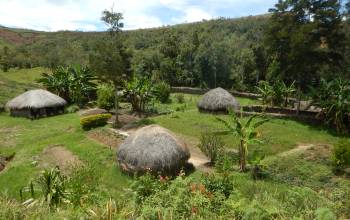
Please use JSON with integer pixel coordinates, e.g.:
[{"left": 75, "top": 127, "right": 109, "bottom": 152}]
[{"left": 90, "top": 8, "right": 131, "bottom": 127}]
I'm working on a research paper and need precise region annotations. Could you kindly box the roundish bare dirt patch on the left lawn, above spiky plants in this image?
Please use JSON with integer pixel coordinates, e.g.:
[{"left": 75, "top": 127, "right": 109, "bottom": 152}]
[{"left": 39, "top": 145, "right": 82, "bottom": 174}]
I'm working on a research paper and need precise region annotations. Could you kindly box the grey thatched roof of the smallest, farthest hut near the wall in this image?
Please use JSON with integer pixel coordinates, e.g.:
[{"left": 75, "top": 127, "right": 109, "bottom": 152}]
[{"left": 197, "top": 88, "right": 240, "bottom": 112}]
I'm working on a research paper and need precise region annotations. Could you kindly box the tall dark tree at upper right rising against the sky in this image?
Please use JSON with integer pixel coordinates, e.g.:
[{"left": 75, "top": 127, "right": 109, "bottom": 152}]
[{"left": 265, "top": 0, "right": 346, "bottom": 90}]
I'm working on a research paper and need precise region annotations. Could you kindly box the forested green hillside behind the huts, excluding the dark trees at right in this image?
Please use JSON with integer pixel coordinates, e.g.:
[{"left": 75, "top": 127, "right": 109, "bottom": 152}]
[{"left": 0, "top": 15, "right": 269, "bottom": 87}]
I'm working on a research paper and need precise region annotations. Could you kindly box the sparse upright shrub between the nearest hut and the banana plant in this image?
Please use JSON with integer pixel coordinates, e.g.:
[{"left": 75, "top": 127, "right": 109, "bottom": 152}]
[{"left": 198, "top": 132, "right": 224, "bottom": 163}]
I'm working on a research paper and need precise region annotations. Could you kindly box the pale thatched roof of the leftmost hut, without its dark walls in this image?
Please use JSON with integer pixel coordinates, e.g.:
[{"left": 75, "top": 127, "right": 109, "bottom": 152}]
[{"left": 6, "top": 89, "right": 67, "bottom": 109}]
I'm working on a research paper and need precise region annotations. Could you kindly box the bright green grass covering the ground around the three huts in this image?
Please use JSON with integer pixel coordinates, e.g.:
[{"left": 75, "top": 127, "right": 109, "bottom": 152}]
[{"left": 0, "top": 69, "right": 350, "bottom": 219}]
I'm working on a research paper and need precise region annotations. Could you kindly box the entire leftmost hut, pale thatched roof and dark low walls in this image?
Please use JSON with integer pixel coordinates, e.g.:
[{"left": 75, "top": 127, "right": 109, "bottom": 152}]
[{"left": 6, "top": 89, "right": 67, "bottom": 119}]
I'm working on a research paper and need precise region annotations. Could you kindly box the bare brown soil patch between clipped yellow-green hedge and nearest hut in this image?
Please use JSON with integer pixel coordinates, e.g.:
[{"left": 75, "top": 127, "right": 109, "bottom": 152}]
[{"left": 88, "top": 129, "right": 124, "bottom": 149}]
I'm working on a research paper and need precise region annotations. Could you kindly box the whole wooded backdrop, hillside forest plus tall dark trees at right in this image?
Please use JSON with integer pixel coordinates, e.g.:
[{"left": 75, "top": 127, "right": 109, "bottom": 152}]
[{"left": 0, "top": 1, "right": 350, "bottom": 91}]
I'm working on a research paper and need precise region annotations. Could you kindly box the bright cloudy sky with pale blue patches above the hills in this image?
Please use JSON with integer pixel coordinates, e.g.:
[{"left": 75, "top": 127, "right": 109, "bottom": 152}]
[{"left": 0, "top": 0, "right": 277, "bottom": 31}]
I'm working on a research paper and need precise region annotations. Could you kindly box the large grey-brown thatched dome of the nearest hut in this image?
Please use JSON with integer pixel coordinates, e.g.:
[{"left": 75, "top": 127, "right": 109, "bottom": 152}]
[{"left": 117, "top": 125, "right": 190, "bottom": 174}]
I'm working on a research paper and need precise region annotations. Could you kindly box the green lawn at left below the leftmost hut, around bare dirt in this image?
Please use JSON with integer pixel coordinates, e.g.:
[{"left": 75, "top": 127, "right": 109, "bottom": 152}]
[{"left": 0, "top": 114, "right": 129, "bottom": 198}]
